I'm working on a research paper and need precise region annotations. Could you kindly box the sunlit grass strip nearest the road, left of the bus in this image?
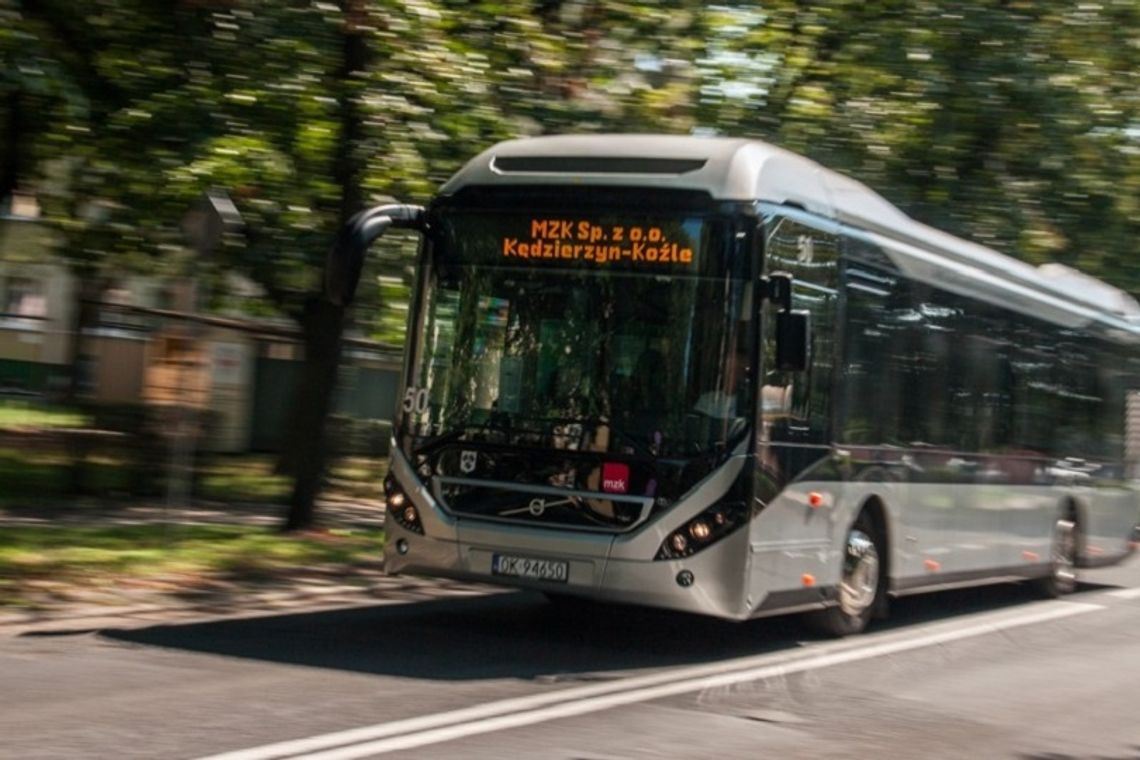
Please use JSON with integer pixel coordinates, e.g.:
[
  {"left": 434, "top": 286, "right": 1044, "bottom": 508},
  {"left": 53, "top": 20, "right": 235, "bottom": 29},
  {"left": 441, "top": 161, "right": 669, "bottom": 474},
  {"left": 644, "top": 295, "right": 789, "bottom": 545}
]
[{"left": 0, "top": 525, "right": 383, "bottom": 606}]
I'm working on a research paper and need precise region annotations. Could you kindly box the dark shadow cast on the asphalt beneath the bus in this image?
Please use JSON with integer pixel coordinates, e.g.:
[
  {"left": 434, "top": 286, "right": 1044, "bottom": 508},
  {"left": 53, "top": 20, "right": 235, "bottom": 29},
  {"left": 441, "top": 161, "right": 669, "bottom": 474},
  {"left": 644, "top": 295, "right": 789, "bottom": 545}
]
[{"left": 103, "top": 585, "right": 1112, "bottom": 680}]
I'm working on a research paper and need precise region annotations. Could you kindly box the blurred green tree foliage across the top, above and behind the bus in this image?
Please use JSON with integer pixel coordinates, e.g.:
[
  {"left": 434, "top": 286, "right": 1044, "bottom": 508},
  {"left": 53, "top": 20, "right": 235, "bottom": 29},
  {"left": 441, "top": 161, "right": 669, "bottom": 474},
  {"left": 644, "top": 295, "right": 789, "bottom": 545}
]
[{"left": 0, "top": 0, "right": 1140, "bottom": 300}]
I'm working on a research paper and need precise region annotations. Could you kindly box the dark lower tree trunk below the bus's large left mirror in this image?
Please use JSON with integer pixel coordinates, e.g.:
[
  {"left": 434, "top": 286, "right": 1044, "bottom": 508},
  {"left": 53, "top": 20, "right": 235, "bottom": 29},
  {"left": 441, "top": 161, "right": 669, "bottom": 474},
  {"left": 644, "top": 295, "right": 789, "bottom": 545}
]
[{"left": 284, "top": 295, "right": 344, "bottom": 531}]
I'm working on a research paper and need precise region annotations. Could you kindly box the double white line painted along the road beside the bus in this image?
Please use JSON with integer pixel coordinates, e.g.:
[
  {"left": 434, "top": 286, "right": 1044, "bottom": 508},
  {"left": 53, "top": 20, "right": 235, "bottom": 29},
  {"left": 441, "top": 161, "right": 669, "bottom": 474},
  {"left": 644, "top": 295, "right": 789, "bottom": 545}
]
[{"left": 201, "top": 602, "right": 1105, "bottom": 760}]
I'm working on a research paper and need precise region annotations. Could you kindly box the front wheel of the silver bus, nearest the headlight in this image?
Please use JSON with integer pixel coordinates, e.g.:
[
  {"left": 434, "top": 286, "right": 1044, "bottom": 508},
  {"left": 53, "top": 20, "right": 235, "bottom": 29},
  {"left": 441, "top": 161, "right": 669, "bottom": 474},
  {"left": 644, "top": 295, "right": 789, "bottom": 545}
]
[{"left": 804, "top": 513, "right": 886, "bottom": 638}]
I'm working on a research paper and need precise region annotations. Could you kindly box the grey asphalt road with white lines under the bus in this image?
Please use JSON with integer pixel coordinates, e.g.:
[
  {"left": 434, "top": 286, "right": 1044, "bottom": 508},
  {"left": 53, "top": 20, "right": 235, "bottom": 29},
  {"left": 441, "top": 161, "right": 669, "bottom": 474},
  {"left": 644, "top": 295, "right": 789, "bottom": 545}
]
[{"left": 0, "top": 561, "right": 1140, "bottom": 760}]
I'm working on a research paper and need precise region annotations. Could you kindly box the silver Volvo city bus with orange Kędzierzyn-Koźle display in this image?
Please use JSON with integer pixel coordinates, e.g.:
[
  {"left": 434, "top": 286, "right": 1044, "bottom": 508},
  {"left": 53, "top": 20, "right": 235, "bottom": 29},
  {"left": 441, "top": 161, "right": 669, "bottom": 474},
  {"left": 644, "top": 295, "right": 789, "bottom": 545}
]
[{"left": 326, "top": 134, "right": 1140, "bottom": 636}]
